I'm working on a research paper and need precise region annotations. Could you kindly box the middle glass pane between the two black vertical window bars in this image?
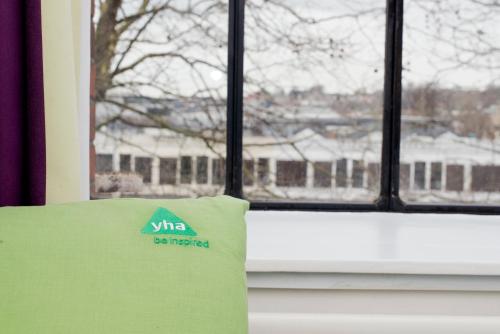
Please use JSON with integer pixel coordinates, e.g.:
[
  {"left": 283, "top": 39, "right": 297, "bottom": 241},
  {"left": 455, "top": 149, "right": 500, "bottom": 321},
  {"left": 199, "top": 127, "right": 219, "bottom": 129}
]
[{"left": 243, "top": 0, "right": 386, "bottom": 202}]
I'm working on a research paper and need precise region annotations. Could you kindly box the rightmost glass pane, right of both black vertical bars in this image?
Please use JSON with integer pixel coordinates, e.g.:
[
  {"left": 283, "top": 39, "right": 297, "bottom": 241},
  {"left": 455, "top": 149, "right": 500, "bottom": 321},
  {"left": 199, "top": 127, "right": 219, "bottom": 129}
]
[{"left": 400, "top": 0, "right": 500, "bottom": 205}]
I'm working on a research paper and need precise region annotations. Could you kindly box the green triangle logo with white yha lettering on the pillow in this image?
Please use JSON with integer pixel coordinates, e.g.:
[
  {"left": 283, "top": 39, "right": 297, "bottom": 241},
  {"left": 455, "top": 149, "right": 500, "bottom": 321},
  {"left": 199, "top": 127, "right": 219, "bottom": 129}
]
[{"left": 141, "top": 208, "right": 197, "bottom": 237}]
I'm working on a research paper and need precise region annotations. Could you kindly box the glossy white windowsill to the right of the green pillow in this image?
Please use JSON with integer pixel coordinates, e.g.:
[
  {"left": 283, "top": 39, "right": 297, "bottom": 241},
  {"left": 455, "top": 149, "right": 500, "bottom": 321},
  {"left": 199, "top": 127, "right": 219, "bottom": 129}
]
[{"left": 247, "top": 211, "right": 500, "bottom": 276}]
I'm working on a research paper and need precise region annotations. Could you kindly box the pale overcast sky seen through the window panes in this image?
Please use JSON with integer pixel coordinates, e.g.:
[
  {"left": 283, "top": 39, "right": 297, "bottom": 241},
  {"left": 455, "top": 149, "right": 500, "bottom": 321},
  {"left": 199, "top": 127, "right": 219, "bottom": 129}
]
[{"left": 106, "top": 0, "right": 500, "bottom": 97}]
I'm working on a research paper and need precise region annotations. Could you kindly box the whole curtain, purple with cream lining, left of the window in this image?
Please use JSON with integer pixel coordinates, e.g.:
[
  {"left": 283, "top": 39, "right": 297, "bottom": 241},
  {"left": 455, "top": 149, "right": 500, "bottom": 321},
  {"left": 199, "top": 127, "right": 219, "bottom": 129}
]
[{"left": 0, "top": 0, "right": 90, "bottom": 206}]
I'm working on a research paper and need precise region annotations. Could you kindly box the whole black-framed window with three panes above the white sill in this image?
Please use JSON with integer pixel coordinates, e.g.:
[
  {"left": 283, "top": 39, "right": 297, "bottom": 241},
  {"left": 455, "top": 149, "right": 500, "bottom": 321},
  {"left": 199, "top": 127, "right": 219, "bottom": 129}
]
[{"left": 93, "top": 0, "right": 500, "bottom": 213}]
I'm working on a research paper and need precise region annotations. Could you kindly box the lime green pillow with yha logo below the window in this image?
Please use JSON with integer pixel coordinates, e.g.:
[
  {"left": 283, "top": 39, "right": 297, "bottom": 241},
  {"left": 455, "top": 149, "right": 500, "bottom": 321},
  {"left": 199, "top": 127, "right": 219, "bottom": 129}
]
[{"left": 0, "top": 196, "right": 248, "bottom": 334}]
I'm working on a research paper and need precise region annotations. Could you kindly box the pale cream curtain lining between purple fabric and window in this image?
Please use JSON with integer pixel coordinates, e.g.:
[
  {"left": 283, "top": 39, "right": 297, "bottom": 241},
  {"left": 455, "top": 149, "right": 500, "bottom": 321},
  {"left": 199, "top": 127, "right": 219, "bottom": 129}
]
[{"left": 42, "top": 0, "right": 90, "bottom": 203}]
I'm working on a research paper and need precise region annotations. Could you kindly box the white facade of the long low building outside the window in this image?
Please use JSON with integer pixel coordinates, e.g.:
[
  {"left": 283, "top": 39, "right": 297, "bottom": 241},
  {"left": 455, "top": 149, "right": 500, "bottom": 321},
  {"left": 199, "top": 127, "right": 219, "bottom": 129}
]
[{"left": 95, "top": 128, "right": 500, "bottom": 203}]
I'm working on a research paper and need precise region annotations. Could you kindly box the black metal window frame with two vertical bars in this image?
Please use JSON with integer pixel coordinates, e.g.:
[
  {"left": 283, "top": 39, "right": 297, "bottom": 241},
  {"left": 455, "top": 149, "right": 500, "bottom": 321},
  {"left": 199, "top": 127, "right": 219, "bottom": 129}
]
[{"left": 225, "top": 0, "right": 500, "bottom": 214}]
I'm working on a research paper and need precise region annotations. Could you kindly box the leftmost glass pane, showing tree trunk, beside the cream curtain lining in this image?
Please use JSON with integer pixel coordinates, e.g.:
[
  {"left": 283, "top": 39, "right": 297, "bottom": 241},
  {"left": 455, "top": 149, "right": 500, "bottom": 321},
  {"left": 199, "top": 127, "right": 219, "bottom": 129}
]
[{"left": 93, "top": 0, "right": 228, "bottom": 197}]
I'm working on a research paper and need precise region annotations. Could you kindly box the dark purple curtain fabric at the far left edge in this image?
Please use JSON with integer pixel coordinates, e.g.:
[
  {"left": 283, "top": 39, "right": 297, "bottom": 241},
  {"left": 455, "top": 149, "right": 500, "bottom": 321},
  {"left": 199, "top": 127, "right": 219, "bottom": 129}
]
[{"left": 0, "top": 0, "right": 45, "bottom": 206}]
